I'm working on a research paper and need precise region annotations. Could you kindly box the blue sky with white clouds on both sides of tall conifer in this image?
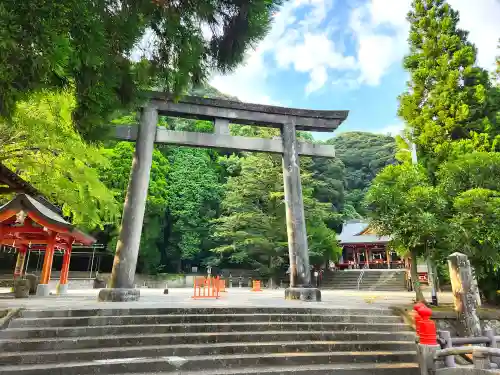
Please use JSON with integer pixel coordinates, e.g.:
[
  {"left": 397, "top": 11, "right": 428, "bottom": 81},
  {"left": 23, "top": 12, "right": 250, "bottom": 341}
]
[{"left": 211, "top": 0, "right": 500, "bottom": 138}]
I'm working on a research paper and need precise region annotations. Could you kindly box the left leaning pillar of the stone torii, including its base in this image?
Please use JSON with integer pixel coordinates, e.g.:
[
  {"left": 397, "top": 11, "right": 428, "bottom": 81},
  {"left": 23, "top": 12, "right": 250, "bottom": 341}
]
[{"left": 99, "top": 105, "right": 158, "bottom": 301}]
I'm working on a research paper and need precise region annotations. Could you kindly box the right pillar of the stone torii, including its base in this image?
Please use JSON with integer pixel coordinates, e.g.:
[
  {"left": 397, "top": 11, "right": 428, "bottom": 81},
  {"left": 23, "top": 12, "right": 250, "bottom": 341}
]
[{"left": 281, "top": 123, "right": 321, "bottom": 301}]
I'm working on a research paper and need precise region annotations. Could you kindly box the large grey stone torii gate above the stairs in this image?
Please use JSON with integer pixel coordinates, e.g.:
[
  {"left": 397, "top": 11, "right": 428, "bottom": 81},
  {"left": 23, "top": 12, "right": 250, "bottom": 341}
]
[{"left": 99, "top": 92, "right": 348, "bottom": 301}]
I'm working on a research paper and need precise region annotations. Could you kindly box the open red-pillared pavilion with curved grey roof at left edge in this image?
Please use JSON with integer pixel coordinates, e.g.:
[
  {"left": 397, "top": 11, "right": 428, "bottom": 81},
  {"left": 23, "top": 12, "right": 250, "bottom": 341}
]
[{"left": 0, "top": 194, "right": 96, "bottom": 296}]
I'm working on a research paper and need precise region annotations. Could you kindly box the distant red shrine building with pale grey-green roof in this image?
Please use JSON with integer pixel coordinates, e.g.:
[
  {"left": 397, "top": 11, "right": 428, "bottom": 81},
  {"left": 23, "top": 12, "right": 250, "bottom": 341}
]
[{"left": 338, "top": 220, "right": 404, "bottom": 269}]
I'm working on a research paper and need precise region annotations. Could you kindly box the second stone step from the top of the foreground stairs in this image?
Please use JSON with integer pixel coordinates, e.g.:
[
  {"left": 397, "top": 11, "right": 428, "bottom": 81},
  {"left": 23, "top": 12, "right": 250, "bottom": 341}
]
[{"left": 9, "top": 314, "right": 401, "bottom": 328}]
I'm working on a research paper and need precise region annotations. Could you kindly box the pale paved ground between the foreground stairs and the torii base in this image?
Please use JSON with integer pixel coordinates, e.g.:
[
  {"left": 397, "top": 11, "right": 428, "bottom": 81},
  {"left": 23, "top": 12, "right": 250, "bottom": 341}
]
[{"left": 0, "top": 288, "right": 452, "bottom": 309}]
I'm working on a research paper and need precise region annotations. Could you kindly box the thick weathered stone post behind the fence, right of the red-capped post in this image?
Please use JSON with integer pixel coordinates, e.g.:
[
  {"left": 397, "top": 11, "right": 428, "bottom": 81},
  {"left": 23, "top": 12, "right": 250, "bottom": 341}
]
[{"left": 448, "top": 253, "right": 481, "bottom": 337}]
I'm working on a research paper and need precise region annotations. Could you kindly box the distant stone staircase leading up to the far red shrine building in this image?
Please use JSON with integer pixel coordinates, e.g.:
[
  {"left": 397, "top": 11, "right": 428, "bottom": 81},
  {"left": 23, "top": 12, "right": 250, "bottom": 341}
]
[{"left": 321, "top": 270, "right": 406, "bottom": 292}]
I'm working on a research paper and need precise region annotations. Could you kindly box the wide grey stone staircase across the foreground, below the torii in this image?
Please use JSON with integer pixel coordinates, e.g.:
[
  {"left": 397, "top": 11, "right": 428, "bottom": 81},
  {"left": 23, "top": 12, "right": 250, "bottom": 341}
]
[{"left": 0, "top": 308, "right": 419, "bottom": 375}]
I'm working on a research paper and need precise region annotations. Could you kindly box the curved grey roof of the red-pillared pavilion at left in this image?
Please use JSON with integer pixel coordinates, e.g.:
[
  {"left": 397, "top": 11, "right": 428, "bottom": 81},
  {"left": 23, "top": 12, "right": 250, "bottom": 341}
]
[{"left": 0, "top": 194, "right": 96, "bottom": 245}]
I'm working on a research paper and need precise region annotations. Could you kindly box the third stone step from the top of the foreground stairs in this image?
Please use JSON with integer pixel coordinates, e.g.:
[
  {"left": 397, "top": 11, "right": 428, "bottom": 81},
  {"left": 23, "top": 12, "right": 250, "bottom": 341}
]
[{"left": 0, "top": 322, "right": 410, "bottom": 339}]
